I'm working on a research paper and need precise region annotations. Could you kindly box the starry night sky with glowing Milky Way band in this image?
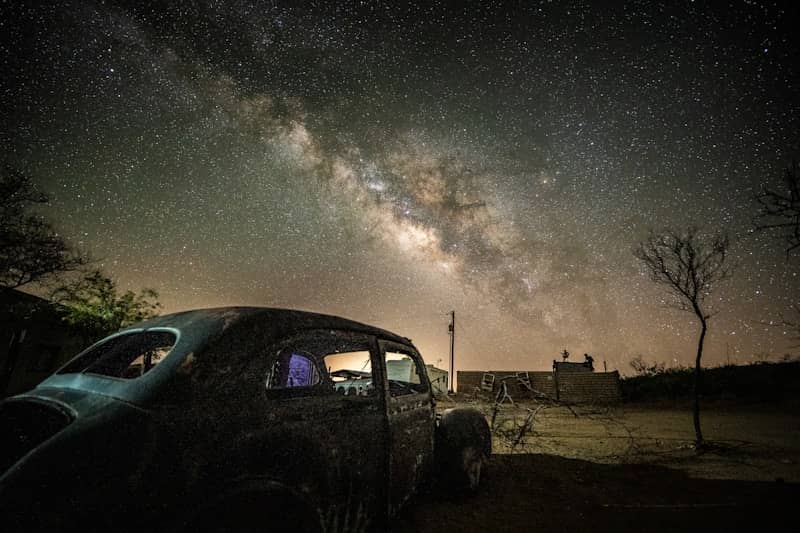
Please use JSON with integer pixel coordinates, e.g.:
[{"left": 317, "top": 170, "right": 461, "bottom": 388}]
[{"left": 0, "top": 0, "right": 800, "bottom": 373}]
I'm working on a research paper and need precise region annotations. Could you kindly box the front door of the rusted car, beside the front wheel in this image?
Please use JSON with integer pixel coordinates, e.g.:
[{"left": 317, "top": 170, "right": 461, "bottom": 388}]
[{"left": 379, "top": 340, "right": 435, "bottom": 514}]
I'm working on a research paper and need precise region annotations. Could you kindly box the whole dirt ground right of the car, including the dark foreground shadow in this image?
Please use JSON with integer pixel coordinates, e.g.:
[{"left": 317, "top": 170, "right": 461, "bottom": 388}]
[{"left": 391, "top": 401, "right": 800, "bottom": 533}]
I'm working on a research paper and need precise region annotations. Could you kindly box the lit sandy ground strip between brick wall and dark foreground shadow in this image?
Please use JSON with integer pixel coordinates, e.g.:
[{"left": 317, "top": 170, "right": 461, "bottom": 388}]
[{"left": 438, "top": 398, "right": 800, "bottom": 483}]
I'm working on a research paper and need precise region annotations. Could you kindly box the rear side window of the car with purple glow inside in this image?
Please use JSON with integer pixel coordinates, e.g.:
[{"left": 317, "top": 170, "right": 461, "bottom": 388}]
[{"left": 266, "top": 331, "right": 377, "bottom": 396}]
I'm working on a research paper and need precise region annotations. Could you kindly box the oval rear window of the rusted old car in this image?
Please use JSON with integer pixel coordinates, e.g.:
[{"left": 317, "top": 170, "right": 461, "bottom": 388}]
[{"left": 58, "top": 331, "right": 177, "bottom": 379}]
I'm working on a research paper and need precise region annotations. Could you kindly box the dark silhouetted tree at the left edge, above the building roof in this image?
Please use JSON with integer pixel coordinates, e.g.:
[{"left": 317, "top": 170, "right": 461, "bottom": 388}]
[{"left": 0, "top": 167, "right": 87, "bottom": 292}]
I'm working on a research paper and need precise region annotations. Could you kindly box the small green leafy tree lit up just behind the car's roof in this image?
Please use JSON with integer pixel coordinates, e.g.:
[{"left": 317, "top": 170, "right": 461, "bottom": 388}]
[{"left": 52, "top": 270, "right": 161, "bottom": 342}]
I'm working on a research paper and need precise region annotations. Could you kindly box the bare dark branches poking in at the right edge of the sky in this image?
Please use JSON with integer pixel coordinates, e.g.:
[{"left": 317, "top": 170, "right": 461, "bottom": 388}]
[{"left": 755, "top": 161, "right": 800, "bottom": 255}]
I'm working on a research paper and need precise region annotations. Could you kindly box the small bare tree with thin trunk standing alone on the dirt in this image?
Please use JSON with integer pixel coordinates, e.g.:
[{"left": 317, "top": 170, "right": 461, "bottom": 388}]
[{"left": 634, "top": 227, "right": 732, "bottom": 449}]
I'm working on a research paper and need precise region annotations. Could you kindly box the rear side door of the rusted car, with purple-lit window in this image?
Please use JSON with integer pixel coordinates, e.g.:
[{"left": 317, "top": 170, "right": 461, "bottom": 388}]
[{"left": 265, "top": 330, "right": 387, "bottom": 531}]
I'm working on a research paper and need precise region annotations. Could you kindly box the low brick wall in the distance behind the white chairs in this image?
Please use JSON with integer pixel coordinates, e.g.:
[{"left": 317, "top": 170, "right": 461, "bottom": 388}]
[{"left": 457, "top": 370, "right": 622, "bottom": 403}]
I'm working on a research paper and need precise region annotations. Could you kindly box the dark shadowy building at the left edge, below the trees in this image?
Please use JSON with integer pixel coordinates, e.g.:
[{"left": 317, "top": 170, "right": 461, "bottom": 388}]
[{"left": 0, "top": 289, "right": 84, "bottom": 397}]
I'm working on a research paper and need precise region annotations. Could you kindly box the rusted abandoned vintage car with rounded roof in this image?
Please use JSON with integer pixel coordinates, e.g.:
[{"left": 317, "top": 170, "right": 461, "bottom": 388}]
[{"left": 0, "top": 307, "right": 491, "bottom": 531}]
